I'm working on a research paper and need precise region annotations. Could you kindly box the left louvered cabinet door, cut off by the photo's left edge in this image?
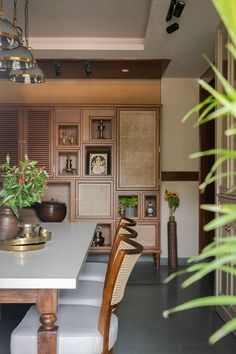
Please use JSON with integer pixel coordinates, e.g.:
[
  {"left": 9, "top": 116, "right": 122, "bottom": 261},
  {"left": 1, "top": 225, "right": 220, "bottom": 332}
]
[{"left": 0, "top": 107, "right": 22, "bottom": 165}]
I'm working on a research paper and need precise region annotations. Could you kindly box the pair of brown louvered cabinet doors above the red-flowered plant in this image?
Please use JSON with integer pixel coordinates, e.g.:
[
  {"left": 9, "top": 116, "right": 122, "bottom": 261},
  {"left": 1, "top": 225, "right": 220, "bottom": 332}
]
[{"left": 0, "top": 106, "right": 52, "bottom": 174}]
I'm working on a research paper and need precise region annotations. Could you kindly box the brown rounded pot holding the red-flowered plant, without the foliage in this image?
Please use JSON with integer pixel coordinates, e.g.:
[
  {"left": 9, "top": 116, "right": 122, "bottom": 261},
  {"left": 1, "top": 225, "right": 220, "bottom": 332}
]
[{"left": 0, "top": 205, "right": 18, "bottom": 240}]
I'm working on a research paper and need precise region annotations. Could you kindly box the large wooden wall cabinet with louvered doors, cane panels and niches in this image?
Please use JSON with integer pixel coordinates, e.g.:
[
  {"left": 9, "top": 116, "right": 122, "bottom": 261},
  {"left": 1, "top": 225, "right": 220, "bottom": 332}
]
[{"left": 0, "top": 105, "right": 161, "bottom": 264}]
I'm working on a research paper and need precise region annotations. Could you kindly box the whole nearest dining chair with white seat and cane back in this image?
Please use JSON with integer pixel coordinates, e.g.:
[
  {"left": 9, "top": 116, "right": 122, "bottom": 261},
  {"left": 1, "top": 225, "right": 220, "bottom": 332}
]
[{"left": 11, "top": 237, "right": 143, "bottom": 354}]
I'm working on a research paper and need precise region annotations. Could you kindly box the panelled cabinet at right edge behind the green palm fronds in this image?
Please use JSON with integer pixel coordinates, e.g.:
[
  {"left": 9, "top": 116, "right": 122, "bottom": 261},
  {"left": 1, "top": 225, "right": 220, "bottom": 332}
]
[{"left": 216, "top": 25, "right": 236, "bottom": 326}]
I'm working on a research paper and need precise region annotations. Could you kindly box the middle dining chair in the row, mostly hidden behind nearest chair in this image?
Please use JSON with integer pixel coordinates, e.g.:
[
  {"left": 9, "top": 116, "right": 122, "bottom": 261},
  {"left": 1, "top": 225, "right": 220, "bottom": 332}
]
[{"left": 58, "top": 225, "right": 138, "bottom": 306}]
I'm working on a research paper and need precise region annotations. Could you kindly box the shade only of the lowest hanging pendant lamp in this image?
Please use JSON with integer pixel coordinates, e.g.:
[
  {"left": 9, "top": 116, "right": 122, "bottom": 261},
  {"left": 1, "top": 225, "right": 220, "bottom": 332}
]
[{"left": 9, "top": 66, "right": 46, "bottom": 84}]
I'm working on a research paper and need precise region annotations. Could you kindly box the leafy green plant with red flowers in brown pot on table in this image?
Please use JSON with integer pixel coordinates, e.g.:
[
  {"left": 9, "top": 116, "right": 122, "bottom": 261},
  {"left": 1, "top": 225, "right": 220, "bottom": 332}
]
[{"left": 0, "top": 155, "right": 48, "bottom": 239}]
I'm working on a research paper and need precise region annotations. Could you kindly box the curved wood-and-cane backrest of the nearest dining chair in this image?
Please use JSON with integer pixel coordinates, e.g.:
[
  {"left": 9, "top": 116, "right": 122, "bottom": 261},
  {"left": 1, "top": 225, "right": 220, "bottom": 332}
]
[{"left": 98, "top": 235, "right": 143, "bottom": 353}]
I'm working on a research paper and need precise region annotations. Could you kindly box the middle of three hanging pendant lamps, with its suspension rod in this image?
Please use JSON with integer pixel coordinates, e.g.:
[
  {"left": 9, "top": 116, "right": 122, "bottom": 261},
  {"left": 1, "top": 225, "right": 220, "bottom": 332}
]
[{"left": 0, "top": 0, "right": 37, "bottom": 70}]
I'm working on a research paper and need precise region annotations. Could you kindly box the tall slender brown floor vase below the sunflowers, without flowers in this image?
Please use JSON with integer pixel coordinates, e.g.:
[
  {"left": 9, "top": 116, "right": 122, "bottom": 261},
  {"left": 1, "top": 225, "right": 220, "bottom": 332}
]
[{"left": 167, "top": 216, "right": 178, "bottom": 268}]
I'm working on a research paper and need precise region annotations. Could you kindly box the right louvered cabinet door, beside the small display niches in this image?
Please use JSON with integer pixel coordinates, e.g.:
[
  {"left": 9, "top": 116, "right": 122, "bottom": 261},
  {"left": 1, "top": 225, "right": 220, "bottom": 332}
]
[{"left": 23, "top": 107, "right": 53, "bottom": 175}]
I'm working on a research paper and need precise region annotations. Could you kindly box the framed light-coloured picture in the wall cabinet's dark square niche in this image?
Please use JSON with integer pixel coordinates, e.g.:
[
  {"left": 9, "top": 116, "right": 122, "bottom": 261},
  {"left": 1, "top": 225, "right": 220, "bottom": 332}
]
[{"left": 89, "top": 152, "right": 108, "bottom": 176}]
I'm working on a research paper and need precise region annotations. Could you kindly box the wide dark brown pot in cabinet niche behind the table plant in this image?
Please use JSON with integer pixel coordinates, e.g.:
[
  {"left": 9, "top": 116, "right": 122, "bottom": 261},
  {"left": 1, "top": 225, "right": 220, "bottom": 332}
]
[{"left": 35, "top": 200, "right": 67, "bottom": 222}]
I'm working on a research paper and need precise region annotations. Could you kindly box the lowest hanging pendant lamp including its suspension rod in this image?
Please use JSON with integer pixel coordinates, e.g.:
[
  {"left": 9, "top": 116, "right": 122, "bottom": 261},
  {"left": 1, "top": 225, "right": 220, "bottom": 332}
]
[{"left": 9, "top": 0, "right": 46, "bottom": 84}]
